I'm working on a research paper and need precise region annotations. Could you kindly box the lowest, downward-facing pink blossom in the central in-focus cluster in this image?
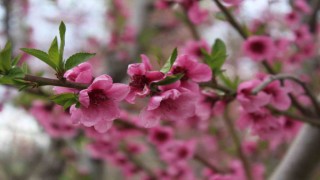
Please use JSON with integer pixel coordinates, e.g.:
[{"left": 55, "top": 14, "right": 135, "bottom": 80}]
[{"left": 140, "top": 88, "right": 197, "bottom": 127}]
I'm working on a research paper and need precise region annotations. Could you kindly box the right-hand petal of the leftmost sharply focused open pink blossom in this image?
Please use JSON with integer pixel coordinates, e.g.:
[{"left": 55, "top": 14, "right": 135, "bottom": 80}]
[{"left": 106, "top": 83, "right": 130, "bottom": 101}]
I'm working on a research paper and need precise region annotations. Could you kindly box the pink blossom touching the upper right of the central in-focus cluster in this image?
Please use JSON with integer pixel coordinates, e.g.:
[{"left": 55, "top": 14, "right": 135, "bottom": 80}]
[{"left": 171, "top": 55, "right": 212, "bottom": 82}]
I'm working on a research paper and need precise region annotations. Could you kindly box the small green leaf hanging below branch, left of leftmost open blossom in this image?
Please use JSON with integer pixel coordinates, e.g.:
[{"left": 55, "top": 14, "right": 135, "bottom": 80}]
[{"left": 50, "top": 93, "right": 78, "bottom": 109}]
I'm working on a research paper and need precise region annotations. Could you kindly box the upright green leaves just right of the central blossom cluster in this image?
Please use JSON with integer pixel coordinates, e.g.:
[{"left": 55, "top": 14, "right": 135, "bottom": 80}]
[{"left": 202, "top": 39, "right": 228, "bottom": 75}]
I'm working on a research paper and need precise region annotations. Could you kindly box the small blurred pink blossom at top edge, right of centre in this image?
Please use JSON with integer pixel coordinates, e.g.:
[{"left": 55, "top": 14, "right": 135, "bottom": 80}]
[{"left": 188, "top": 3, "right": 209, "bottom": 25}]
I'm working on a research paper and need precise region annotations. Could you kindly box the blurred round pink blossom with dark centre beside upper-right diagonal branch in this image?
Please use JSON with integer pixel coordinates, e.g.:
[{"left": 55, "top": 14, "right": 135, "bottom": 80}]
[{"left": 242, "top": 36, "right": 275, "bottom": 61}]
